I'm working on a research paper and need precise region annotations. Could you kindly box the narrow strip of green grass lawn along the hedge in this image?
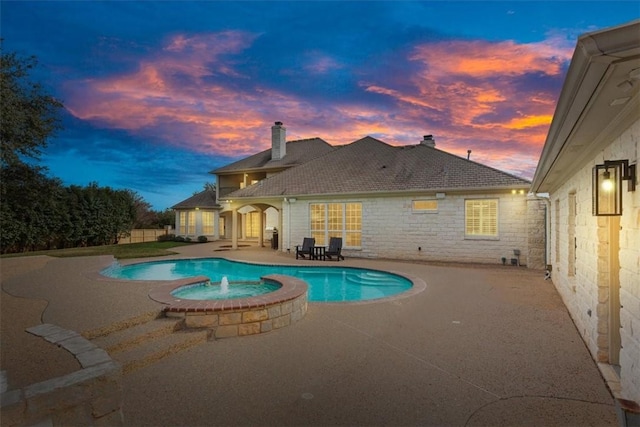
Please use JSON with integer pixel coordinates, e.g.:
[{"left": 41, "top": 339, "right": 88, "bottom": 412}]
[{"left": 2, "top": 242, "right": 191, "bottom": 259}]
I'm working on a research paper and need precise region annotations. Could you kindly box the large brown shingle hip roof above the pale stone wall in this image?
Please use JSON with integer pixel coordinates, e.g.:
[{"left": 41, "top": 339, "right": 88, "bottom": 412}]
[{"left": 226, "top": 136, "right": 531, "bottom": 198}]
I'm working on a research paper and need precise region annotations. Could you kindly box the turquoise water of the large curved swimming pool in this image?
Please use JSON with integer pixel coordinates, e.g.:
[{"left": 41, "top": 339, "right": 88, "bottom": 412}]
[{"left": 101, "top": 258, "right": 412, "bottom": 302}]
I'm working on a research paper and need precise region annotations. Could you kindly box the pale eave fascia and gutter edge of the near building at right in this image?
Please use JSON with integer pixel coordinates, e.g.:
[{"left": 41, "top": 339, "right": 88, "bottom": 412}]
[{"left": 531, "top": 20, "right": 640, "bottom": 193}]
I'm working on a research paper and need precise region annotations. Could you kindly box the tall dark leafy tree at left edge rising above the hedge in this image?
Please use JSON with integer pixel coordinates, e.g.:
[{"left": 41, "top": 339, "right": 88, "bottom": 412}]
[{"left": 0, "top": 46, "right": 65, "bottom": 252}]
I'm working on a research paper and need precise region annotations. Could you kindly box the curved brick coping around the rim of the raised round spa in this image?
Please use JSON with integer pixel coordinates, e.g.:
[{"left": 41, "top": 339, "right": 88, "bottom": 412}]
[{"left": 149, "top": 274, "right": 308, "bottom": 313}]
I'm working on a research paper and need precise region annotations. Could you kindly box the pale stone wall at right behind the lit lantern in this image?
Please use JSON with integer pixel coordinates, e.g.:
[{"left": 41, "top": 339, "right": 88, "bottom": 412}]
[{"left": 549, "top": 121, "right": 640, "bottom": 402}]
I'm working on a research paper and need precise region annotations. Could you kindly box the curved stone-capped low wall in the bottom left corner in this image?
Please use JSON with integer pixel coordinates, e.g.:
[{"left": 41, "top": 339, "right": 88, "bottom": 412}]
[{"left": 0, "top": 324, "right": 124, "bottom": 426}]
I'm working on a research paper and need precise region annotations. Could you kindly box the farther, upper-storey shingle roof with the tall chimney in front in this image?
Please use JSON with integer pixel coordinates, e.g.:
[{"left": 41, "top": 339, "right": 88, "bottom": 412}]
[{"left": 210, "top": 138, "right": 335, "bottom": 175}]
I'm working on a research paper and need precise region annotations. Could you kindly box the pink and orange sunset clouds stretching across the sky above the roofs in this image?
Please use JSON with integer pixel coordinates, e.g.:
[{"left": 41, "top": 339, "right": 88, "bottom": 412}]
[{"left": 65, "top": 31, "right": 572, "bottom": 176}]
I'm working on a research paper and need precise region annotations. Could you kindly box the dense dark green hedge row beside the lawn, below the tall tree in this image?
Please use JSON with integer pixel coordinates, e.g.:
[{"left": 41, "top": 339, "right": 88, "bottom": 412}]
[{"left": 0, "top": 164, "right": 137, "bottom": 253}]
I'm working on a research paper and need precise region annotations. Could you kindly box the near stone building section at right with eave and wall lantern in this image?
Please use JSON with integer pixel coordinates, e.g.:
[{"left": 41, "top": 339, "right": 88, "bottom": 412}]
[{"left": 532, "top": 21, "right": 640, "bottom": 414}]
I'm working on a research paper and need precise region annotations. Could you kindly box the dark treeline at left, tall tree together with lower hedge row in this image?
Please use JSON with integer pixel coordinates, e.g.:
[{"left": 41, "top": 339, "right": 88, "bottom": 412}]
[{"left": 0, "top": 46, "right": 174, "bottom": 253}]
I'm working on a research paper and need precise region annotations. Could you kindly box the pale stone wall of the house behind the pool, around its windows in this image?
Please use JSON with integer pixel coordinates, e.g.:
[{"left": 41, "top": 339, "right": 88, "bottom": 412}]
[{"left": 281, "top": 191, "right": 544, "bottom": 268}]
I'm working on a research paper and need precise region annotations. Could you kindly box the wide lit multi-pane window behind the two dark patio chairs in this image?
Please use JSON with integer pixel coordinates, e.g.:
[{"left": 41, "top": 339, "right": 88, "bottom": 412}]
[{"left": 309, "top": 203, "right": 362, "bottom": 248}]
